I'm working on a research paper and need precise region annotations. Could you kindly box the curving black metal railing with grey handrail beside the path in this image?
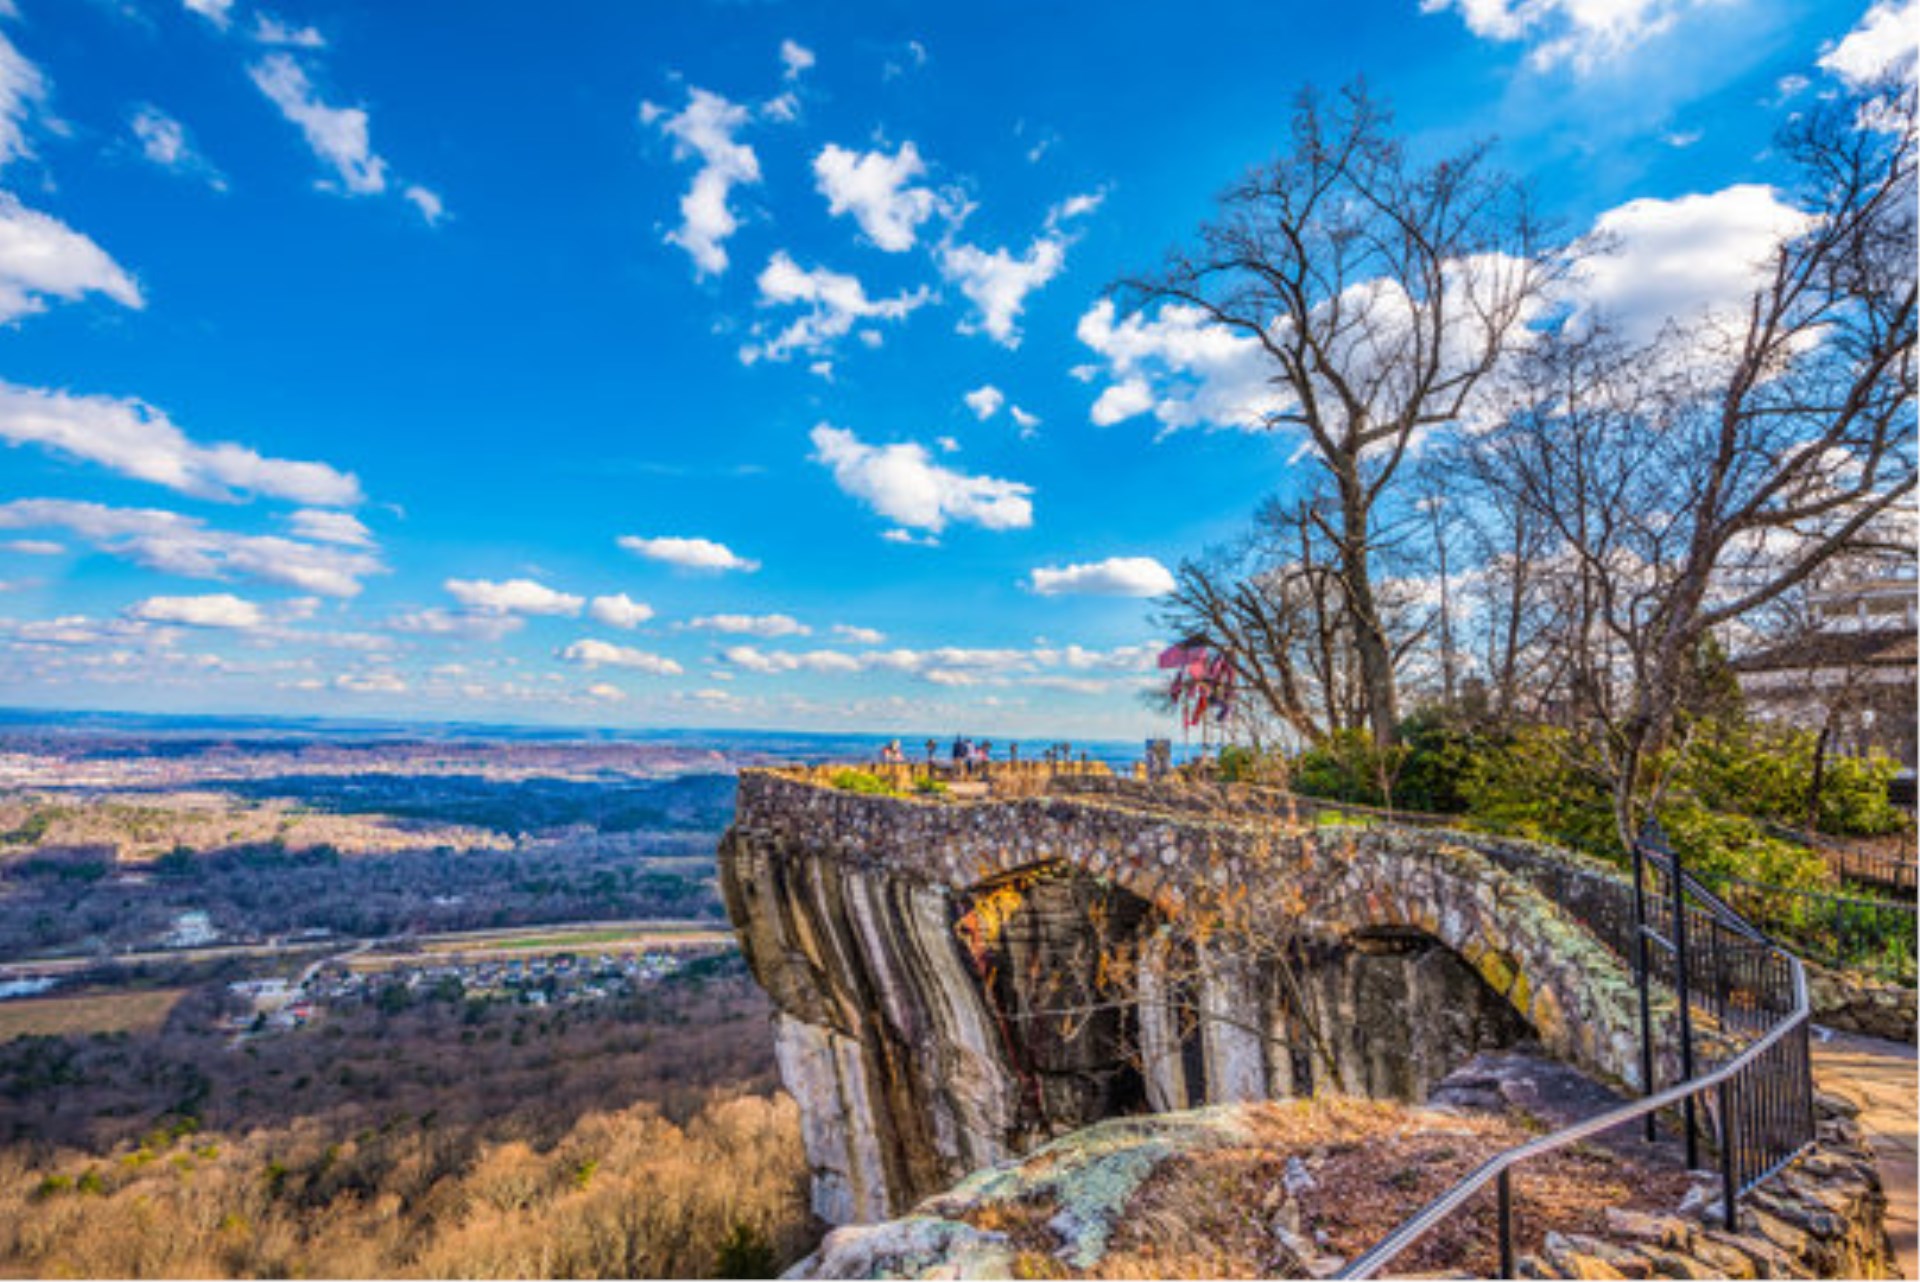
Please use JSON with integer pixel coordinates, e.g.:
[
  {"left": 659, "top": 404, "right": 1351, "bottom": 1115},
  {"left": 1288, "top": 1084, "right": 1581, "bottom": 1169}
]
[{"left": 1338, "top": 831, "right": 1816, "bottom": 1278}]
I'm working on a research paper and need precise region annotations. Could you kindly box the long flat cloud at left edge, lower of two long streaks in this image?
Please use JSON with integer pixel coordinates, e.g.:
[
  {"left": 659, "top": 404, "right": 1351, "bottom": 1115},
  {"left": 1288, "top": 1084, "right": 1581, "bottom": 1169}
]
[{"left": 0, "top": 499, "right": 386, "bottom": 597}]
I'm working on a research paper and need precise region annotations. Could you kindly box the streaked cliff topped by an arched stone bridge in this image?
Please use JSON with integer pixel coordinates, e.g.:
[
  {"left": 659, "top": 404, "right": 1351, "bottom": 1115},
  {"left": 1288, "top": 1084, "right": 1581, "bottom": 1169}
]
[{"left": 720, "top": 770, "right": 1638, "bottom": 1223}]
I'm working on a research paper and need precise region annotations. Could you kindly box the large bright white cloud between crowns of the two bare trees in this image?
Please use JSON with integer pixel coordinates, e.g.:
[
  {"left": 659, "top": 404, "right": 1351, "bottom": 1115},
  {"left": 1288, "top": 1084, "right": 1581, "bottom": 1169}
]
[{"left": 1565, "top": 184, "right": 1807, "bottom": 342}]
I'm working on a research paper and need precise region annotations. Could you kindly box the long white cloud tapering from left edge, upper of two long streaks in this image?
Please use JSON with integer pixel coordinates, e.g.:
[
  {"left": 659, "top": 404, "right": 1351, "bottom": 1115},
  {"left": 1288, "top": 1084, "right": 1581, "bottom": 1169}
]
[{"left": 0, "top": 382, "right": 361, "bottom": 507}]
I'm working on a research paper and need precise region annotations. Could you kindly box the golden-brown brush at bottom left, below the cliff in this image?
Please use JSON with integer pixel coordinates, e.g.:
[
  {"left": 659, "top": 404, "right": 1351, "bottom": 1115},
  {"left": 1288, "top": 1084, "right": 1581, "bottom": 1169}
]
[{"left": 0, "top": 1096, "right": 808, "bottom": 1278}]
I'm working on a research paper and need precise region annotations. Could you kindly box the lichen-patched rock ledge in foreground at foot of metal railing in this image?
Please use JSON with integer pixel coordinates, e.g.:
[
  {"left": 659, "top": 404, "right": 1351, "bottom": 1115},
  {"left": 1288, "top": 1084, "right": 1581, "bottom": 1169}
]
[{"left": 789, "top": 1102, "right": 1891, "bottom": 1278}]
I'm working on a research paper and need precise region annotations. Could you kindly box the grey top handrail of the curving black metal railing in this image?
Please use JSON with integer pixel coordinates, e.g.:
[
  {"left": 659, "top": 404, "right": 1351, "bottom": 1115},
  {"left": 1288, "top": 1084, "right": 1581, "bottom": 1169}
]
[{"left": 1334, "top": 844, "right": 1812, "bottom": 1278}]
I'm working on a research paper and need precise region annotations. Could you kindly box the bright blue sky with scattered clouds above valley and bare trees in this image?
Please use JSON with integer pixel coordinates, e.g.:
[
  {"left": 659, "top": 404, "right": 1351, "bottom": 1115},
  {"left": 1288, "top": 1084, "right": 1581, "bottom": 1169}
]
[{"left": 0, "top": 0, "right": 1914, "bottom": 737}]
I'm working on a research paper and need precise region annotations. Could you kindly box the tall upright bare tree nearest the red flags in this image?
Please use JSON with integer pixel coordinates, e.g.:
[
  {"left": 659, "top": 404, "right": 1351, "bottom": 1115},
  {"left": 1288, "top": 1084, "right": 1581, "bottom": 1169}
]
[{"left": 1121, "top": 84, "right": 1546, "bottom": 745}]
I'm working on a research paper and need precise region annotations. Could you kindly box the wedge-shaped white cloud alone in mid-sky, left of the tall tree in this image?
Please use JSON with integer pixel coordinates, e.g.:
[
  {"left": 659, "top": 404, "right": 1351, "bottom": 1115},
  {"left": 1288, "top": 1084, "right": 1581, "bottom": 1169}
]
[{"left": 812, "top": 422, "right": 1033, "bottom": 534}]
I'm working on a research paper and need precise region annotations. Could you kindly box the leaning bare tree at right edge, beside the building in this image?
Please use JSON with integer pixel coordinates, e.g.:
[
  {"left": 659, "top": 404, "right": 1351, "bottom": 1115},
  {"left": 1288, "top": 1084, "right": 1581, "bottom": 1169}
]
[{"left": 1484, "top": 86, "right": 1916, "bottom": 843}]
